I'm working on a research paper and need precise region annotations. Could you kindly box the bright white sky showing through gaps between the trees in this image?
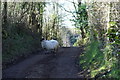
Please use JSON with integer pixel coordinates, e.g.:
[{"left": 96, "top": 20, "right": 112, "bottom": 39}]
[{"left": 46, "top": 0, "right": 77, "bottom": 28}]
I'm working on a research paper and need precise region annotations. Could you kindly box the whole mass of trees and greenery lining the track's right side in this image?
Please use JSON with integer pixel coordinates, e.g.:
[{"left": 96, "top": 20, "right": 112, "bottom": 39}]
[{"left": 74, "top": 2, "right": 120, "bottom": 79}]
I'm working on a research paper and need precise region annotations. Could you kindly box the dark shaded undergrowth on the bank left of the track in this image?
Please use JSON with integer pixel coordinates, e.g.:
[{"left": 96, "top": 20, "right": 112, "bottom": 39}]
[{"left": 2, "top": 23, "right": 40, "bottom": 67}]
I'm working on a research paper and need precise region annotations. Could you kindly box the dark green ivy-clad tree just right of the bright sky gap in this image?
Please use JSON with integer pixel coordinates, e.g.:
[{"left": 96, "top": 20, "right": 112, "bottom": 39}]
[{"left": 70, "top": 4, "right": 88, "bottom": 38}]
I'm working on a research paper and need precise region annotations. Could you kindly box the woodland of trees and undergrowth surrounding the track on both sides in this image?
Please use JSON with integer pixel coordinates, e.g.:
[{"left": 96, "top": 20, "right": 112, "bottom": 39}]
[{"left": 1, "top": 0, "right": 120, "bottom": 79}]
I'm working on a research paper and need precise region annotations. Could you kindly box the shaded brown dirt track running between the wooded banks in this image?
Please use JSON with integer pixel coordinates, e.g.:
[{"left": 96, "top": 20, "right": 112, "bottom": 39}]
[{"left": 3, "top": 47, "right": 82, "bottom": 78}]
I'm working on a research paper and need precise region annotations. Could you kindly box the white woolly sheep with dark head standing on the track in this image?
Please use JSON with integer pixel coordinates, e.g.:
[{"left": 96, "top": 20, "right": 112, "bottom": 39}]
[{"left": 41, "top": 39, "right": 59, "bottom": 52}]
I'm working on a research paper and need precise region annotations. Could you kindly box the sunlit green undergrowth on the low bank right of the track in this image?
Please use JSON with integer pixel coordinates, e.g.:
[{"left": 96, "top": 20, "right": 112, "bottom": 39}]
[{"left": 80, "top": 40, "right": 120, "bottom": 79}]
